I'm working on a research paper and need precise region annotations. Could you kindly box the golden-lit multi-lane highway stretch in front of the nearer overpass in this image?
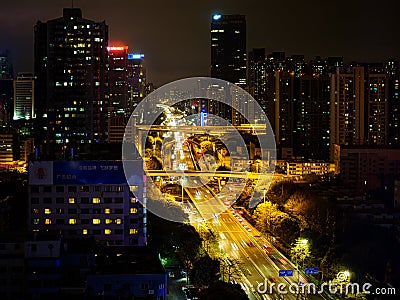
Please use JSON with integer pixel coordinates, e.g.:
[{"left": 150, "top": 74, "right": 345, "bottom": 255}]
[{"left": 186, "top": 180, "right": 322, "bottom": 300}]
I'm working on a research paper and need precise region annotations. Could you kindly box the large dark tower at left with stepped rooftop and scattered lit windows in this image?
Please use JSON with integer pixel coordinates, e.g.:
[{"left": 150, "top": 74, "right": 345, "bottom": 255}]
[{"left": 34, "top": 8, "right": 108, "bottom": 157}]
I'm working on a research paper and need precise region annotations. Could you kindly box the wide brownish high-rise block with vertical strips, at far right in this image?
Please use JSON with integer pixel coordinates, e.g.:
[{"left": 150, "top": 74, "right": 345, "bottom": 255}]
[{"left": 330, "top": 64, "right": 389, "bottom": 154}]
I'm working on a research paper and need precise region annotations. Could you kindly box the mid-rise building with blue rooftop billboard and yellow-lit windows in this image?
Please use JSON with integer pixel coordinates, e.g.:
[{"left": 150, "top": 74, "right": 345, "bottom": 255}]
[{"left": 28, "top": 160, "right": 146, "bottom": 246}]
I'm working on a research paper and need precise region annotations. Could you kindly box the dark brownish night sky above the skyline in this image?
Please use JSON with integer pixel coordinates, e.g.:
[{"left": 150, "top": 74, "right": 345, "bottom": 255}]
[{"left": 0, "top": 0, "right": 400, "bottom": 86}]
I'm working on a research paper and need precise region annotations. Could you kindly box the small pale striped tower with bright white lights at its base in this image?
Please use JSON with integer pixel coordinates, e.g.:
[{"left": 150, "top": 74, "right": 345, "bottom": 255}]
[{"left": 13, "top": 73, "right": 35, "bottom": 120}]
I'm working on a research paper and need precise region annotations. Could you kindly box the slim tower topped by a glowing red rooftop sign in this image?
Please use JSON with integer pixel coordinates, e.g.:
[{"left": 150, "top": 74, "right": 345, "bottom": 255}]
[{"left": 108, "top": 46, "right": 129, "bottom": 115}]
